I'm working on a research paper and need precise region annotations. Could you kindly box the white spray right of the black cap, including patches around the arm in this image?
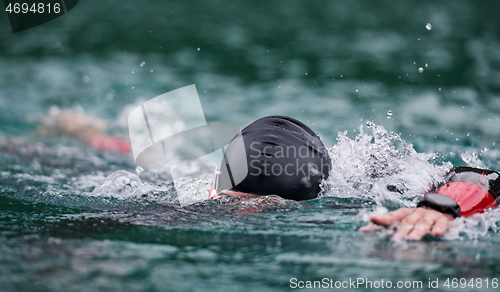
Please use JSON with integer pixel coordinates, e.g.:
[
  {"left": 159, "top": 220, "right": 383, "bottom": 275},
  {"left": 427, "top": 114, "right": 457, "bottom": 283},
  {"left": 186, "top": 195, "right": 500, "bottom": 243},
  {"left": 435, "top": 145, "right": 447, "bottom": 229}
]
[{"left": 322, "top": 122, "right": 500, "bottom": 240}]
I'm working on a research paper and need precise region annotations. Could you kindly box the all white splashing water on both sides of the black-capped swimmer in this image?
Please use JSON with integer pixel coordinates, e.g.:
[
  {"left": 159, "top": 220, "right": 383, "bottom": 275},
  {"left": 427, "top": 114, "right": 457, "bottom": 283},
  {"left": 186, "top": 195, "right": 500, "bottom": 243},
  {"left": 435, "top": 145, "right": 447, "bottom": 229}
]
[{"left": 89, "top": 122, "right": 500, "bottom": 240}]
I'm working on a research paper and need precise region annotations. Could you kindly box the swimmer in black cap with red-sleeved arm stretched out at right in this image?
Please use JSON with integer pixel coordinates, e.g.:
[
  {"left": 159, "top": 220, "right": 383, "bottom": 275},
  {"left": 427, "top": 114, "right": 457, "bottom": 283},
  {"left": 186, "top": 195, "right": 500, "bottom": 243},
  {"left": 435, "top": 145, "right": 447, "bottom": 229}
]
[{"left": 209, "top": 116, "right": 500, "bottom": 241}]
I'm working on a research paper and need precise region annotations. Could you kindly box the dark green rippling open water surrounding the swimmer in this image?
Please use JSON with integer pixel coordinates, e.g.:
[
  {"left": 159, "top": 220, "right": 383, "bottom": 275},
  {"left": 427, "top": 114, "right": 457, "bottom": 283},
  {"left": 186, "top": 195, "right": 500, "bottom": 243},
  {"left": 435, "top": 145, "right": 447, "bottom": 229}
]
[{"left": 0, "top": 0, "right": 500, "bottom": 291}]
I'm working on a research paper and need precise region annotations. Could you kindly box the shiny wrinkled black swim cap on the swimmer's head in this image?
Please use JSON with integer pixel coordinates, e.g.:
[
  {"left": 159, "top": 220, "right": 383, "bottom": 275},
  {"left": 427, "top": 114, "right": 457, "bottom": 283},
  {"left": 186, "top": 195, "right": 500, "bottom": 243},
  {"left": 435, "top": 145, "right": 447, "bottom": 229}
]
[{"left": 219, "top": 116, "right": 331, "bottom": 200}]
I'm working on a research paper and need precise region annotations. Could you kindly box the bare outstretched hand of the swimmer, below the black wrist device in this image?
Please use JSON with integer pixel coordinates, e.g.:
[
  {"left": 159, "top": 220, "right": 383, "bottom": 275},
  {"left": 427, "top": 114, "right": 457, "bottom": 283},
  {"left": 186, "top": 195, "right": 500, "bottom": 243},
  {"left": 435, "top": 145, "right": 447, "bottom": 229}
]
[{"left": 359, "top": 208, "right": 453, "bottom": 241}]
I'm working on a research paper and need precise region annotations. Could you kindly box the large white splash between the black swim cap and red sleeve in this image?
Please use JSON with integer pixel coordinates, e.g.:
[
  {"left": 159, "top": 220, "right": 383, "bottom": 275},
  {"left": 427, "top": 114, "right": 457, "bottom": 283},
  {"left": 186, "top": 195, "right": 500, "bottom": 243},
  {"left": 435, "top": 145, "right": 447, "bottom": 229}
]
[{"left": 323, "top": 122, "right": 453, "bottom": 206}]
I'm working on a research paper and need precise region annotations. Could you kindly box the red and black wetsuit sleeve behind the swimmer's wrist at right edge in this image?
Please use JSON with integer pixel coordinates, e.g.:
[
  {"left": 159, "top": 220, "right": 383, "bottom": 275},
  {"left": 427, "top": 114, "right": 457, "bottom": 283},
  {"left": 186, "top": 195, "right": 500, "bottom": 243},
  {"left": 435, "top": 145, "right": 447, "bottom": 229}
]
[{"left": 435, "top": 167, "right": 500, "bottom": 217}]
